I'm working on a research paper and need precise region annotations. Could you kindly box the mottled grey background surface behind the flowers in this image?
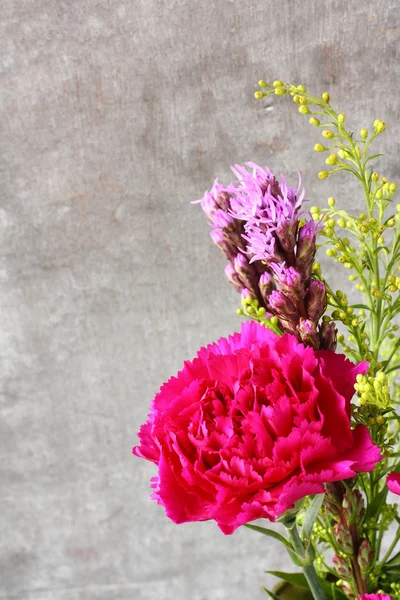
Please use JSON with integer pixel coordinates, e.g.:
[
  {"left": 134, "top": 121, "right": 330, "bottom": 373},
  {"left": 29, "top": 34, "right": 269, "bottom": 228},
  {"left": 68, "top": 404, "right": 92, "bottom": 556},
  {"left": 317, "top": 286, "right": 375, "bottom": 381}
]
[{"left": 0, "top": 0, "right": 400, "bottom": 600}]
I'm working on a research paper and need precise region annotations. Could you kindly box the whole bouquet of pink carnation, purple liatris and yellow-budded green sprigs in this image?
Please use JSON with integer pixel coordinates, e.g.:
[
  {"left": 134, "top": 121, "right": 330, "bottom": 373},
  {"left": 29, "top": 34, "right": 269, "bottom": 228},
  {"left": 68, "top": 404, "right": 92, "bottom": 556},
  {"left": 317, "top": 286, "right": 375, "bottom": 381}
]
[{"left": 133, "top": 81, "right": 400, "bottom": 600}]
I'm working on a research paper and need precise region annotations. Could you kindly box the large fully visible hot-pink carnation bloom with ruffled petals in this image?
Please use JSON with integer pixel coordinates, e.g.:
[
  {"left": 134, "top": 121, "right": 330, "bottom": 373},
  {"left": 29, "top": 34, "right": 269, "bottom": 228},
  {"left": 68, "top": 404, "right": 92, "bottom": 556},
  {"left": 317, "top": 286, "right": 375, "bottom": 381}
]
[{"left": 133, "top": 322, "right": 381, "bottom": 534}]
